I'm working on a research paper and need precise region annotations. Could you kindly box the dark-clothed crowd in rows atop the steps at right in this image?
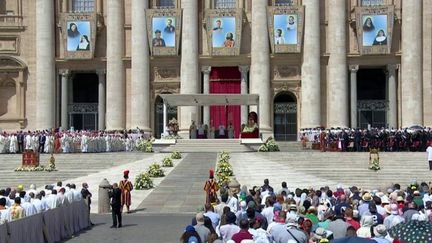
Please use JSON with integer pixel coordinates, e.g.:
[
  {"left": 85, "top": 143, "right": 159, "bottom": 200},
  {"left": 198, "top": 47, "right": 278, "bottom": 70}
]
[{"left": 300, "top": 127, "right": 432, "bottom": 152}]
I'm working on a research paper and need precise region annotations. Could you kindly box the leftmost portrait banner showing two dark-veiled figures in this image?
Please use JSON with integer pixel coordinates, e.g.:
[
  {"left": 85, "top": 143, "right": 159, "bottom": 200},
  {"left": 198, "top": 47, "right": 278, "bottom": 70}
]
[{"left": 62, "top": 13, "right": 96, "bottom": 59}]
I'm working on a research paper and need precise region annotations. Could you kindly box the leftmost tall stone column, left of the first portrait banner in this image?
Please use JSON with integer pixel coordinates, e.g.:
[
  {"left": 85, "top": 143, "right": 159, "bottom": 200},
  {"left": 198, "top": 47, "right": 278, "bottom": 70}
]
[{"left": 34, "top": 0, "right": 56, "bottom": 129}]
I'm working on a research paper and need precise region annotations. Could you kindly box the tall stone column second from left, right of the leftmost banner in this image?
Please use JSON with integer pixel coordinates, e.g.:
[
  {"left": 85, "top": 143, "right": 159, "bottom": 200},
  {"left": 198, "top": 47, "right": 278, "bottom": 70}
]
[{"left": 106, "top": 0, "right": 124, "bottom": 130}]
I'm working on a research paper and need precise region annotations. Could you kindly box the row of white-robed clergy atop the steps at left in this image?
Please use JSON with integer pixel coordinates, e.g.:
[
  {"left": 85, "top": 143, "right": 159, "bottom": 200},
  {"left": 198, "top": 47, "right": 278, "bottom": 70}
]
[{"left": 0, "top": 130, "right": 148, "bottom": 154}]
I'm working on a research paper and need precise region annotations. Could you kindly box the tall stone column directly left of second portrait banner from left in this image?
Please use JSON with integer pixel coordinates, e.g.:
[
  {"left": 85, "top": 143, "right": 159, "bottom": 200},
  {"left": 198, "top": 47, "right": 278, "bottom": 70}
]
[{"left": 130, "top": 0, "right": 151, "bottom": 132}]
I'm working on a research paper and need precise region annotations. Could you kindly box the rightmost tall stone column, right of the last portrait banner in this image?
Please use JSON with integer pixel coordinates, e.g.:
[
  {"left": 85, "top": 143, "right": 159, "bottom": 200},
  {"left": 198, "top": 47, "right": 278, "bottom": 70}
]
[{"left": 401, "top": 0, "right": 423, "bottom": 127}]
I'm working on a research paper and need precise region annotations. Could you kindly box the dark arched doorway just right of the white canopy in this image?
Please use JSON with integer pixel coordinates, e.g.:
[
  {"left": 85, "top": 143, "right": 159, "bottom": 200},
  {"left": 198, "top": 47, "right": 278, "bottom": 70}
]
[{"left": 273, "top": 92, "right": 297, "bottom": 141}]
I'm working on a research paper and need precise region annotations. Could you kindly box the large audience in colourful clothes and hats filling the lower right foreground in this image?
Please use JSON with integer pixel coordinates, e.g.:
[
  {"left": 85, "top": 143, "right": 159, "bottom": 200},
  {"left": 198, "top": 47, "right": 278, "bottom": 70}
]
[{"left": 180, "top": 179, "right": 432, "bottom": 243}]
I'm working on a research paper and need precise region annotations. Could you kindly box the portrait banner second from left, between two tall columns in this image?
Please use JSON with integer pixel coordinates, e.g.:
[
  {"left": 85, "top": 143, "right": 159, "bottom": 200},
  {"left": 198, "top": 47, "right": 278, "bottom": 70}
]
[{"left": 146, "top": 9, "right": 181, "bottom": 56}]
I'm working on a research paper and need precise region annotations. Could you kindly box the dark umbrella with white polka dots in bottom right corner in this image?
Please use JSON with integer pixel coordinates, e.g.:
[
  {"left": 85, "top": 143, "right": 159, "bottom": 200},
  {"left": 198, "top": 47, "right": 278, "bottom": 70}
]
[{"left": 389, "top": 220, "right": 432, "bottom": 242}]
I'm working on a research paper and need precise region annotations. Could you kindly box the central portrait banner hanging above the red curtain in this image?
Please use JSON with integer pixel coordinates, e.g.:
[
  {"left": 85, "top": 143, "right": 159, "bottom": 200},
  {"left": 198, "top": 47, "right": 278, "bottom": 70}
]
[{"left": 205, "top": 9, "right": 242, "bottom": 56}]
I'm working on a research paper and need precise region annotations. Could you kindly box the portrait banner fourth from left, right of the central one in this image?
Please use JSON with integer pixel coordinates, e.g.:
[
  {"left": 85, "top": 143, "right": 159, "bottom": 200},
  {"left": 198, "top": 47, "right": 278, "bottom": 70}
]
[{"left": 267, "top": 6, "right": 304, "bottom": 53}]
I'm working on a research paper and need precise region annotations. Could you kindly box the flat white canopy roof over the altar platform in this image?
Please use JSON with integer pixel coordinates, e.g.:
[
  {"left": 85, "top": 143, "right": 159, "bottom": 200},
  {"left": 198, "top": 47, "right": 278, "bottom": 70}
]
[{"left": 159, "top": 94, "right": 259, "bottom": 106}]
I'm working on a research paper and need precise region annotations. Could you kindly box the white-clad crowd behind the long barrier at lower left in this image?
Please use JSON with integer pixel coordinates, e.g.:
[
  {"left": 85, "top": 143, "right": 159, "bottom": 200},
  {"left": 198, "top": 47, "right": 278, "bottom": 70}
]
[{"left": 0, "top": 182, "right": 91, "bottom": 224}]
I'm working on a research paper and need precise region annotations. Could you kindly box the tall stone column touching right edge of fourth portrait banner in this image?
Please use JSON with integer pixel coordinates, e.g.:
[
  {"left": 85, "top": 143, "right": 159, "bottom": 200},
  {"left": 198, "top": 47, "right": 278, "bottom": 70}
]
[{"left": 300, "top": 0, "right": 322, "bottom": 128}]
